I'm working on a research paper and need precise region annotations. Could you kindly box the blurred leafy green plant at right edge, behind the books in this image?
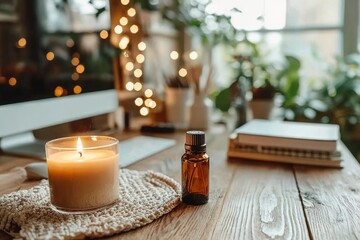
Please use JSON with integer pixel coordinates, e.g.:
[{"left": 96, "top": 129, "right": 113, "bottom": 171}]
[{"left": 284, "top": 53, "right": 360, "bottom": 158}]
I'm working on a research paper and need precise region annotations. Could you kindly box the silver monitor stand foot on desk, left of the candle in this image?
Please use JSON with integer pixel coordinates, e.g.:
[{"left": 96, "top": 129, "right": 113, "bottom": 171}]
[{"left": 0, "top": 132, "right": 46, "bottom": 160}]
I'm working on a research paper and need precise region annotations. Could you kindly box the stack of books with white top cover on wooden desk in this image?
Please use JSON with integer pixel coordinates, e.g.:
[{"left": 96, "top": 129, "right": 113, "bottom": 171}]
[{"left": 228, "top": 119, "right": 342, "bottom": 167}]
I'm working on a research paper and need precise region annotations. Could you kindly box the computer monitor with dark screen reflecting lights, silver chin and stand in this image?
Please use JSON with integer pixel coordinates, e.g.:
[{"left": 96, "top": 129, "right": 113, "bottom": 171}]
[{"left": 0, "top": 0, "right": 118, "bottom": 158}]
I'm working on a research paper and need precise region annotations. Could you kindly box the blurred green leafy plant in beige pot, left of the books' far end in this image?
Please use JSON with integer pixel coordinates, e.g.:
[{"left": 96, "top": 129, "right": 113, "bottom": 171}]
[{"left": 215, "top": 40, "right": 300, "bottom": 126}]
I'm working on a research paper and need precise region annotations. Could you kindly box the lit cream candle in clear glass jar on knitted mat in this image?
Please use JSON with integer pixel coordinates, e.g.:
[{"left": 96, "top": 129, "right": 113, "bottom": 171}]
[{"left": 46, "top": 136, "right": 119, "bottom": 212}]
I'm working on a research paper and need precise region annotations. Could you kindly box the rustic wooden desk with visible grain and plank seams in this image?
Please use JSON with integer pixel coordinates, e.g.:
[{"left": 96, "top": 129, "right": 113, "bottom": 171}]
[{"left": 0, "top": 128, "right": 360, "bottom": 240}]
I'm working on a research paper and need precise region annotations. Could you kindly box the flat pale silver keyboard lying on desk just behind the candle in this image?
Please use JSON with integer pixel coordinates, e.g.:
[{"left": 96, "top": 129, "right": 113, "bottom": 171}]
[{"left": 119, "top": 136, "right": 176, "bottom": 168}]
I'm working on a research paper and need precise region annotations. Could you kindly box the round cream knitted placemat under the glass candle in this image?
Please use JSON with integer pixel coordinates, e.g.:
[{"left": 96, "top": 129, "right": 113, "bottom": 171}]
[{"left": 0, "top": 169, "right": 180, "bottom": 239}]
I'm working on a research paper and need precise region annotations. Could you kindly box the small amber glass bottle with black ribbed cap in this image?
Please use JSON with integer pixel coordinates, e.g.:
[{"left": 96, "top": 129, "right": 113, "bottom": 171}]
[{"left": 181, "top": 131, "right": 209, "bottom": 205}]
